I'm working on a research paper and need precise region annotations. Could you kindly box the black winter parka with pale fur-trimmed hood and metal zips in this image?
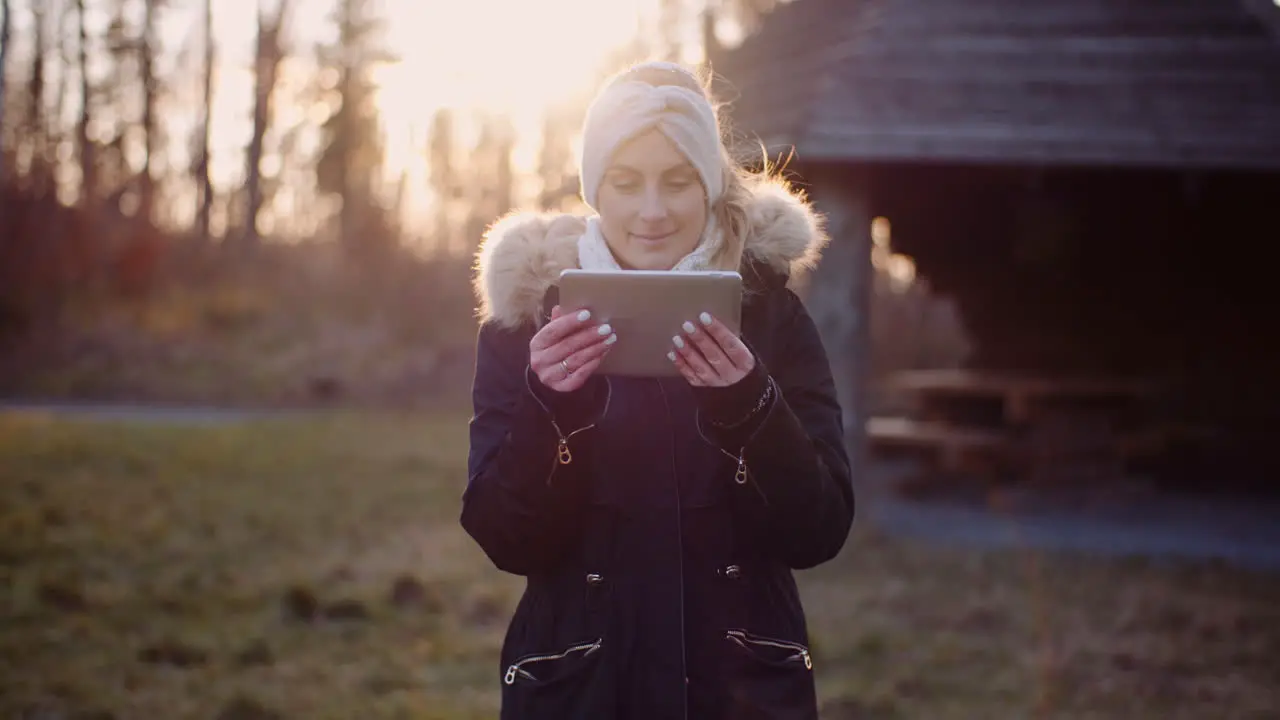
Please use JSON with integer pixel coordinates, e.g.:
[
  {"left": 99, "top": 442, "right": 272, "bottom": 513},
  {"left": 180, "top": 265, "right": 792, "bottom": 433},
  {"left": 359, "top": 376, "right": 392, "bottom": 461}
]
[{"left": 461, "top": 179, "right": 854, "bottom": 720}]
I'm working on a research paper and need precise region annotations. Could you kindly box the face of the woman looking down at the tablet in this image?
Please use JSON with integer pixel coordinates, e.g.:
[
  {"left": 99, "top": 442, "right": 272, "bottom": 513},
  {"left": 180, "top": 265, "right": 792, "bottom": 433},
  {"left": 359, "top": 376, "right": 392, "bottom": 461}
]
[{"left": 598, "top": 131, "right": 707, "bottom": 270}]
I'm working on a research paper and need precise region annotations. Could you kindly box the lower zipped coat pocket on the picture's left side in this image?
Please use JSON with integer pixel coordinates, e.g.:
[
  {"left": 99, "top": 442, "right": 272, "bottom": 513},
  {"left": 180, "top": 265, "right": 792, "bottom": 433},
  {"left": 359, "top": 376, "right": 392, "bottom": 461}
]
[{"left": 502, "top": 639, "right": 603, "bottom": 720}]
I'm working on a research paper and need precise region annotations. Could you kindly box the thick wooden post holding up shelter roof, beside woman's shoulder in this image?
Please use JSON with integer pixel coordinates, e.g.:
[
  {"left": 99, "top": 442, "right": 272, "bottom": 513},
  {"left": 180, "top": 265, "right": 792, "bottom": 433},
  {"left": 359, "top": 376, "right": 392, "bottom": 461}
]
[{"left": 805, "top": 168, "right": 874, "bottom": 479}]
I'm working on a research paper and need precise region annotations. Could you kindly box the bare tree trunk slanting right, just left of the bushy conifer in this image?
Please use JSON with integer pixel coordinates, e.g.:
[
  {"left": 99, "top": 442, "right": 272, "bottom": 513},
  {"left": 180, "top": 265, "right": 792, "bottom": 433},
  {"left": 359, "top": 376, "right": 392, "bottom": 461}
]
[{"left": 241, "top": 0, "right": 289, "bottom": 254}]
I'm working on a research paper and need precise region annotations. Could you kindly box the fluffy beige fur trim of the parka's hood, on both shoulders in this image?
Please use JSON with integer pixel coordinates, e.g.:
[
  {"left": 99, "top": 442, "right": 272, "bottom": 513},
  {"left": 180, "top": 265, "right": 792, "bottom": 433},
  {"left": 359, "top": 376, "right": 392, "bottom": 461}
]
[{"left": 475, "top": 179, "right": 828, "bottom": 328}]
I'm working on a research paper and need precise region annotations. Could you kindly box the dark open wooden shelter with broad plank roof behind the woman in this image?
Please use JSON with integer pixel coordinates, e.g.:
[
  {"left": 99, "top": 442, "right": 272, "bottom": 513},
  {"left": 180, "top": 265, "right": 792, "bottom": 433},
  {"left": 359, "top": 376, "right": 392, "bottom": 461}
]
[{"left": 708, "top": 0, "right": 1280, "bottom": 488}]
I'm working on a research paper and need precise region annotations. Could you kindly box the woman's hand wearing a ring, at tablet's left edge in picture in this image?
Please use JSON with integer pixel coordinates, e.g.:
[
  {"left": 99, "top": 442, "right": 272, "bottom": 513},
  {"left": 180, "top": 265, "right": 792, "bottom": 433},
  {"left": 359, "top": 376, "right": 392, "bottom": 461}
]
[{"left": 529, "top": 305, "right": 618, "bottom": 392}]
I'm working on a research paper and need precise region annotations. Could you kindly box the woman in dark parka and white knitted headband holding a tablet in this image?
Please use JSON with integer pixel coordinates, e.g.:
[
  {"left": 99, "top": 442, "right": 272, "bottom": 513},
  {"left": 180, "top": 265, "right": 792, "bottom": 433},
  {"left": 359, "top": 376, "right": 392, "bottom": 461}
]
[{"left": 462, "top": 63, "right": 854, "bottom": 720}]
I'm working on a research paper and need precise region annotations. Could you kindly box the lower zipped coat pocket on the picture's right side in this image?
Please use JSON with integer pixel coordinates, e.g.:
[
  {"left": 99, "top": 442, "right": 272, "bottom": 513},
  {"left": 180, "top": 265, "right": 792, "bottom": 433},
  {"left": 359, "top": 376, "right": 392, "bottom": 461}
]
[{"left": 724, "top": 629, "right": 818, "bottom": 720}]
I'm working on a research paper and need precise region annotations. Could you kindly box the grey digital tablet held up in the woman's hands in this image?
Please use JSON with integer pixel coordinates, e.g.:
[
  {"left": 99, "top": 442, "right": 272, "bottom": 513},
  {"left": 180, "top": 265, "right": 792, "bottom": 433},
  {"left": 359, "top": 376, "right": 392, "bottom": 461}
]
[{"left": 559, "top": 269, "right": 742, "bottom": 377}]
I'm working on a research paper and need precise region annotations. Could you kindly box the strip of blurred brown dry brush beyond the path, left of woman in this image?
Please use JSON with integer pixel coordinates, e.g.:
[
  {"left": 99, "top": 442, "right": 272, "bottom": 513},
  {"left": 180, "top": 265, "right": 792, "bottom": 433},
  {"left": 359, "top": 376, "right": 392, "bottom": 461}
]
[{"left": 0, "top": 243, "right": 475, "bottom": 406}]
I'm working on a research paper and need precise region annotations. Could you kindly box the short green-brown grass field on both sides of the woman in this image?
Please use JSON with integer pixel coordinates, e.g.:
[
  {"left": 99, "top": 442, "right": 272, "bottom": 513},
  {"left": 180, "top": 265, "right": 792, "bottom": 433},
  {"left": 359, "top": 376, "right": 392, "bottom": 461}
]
[{"left": 0, "top": 415, "right": 1280, "bottom": 720}]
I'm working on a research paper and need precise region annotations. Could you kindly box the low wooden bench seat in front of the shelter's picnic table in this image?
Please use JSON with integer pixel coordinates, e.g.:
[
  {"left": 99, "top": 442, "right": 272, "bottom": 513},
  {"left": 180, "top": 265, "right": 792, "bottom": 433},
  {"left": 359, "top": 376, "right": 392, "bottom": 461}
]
[{"left": 867, "top": 416, "right": 1015, "bottom": 471}]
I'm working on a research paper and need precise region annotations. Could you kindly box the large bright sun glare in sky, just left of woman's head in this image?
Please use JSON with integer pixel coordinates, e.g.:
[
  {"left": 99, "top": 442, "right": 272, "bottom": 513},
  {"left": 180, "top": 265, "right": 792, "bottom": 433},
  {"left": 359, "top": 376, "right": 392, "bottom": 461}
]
[{"left": 378, "top": 0, "right": 652, "bottom": 221}]
